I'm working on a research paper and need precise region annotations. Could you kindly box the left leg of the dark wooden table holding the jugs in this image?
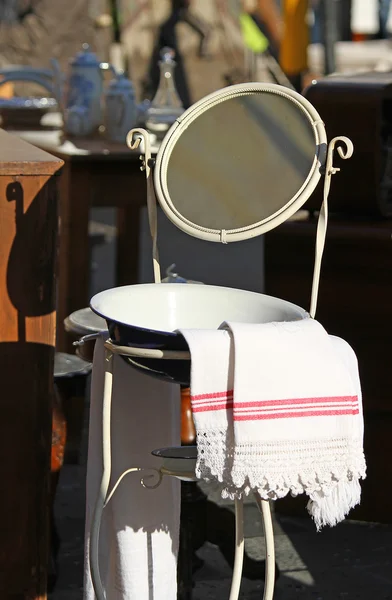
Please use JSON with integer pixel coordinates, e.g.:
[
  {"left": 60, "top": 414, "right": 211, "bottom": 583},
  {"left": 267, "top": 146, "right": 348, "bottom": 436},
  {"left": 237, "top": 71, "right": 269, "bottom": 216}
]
[{"left": 57, "top": 161, "right": 91, "bottom": 352}]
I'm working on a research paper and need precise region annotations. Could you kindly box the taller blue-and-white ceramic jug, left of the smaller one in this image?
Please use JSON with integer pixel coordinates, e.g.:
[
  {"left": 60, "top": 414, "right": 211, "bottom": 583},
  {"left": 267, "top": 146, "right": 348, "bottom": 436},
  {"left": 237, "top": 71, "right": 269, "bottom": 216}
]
[{"left": 64, "top": 44, "right": 110, "bottom": 135}]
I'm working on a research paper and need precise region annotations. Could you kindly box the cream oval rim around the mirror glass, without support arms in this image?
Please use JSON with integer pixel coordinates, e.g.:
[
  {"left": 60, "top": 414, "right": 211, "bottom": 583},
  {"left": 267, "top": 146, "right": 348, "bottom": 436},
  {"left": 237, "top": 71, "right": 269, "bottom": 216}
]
[{"left": 154, "top": 83, "right": 327, "bottom": 243}]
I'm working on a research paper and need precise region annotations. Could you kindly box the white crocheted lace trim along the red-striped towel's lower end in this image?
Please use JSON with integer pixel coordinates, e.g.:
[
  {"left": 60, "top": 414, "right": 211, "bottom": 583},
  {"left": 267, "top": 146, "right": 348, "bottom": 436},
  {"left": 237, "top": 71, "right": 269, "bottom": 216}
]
[{"left": 196, "top": 431, "right": 366, "bottom": 504}]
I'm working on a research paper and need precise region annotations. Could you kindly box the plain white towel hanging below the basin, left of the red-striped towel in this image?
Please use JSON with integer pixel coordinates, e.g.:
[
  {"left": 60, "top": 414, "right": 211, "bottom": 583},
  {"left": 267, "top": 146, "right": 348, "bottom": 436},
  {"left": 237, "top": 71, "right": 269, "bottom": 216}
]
[{"left": 84, "top": 339, "right": 180, "bottom": 600}]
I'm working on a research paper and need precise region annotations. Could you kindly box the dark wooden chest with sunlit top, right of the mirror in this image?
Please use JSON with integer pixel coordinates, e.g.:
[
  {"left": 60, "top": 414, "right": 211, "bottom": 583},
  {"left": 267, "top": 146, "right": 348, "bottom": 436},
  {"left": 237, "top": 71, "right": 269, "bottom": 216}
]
[{"left": 304, "top": 71, "right": 392, "bottom": 219}]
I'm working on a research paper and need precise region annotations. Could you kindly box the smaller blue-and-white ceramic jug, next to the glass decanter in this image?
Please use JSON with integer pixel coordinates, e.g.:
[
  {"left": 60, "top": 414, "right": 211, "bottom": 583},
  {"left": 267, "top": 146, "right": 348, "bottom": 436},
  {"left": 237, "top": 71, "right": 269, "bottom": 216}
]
[{"left": 105, "top": 73, "right": 138, "bottom": 144}]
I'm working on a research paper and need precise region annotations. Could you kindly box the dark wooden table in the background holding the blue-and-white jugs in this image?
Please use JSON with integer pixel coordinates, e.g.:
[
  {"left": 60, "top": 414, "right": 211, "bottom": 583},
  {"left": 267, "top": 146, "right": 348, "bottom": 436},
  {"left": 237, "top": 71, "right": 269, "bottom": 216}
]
[{"left": 12, "top": 130, "right": 153, "bottom": 352}]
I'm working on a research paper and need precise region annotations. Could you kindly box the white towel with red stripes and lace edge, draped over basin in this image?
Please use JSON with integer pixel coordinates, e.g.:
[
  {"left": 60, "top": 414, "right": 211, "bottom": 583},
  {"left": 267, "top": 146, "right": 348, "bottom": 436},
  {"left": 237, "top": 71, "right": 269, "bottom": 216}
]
[{"left": 182, "top": 319, "right": 365, "bottom": 529}]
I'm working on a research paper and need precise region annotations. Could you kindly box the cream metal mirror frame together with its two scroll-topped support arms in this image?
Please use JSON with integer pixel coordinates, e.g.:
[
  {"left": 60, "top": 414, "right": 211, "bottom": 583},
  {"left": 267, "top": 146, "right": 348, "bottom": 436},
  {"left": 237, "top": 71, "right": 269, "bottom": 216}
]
[{"left": 127, "top": 83, "right": 354, "bottom": 317}]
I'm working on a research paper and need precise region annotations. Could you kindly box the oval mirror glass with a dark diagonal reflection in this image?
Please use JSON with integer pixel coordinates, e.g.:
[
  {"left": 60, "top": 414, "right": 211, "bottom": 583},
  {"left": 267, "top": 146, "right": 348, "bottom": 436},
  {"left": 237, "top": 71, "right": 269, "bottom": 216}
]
[{"left": 167, "top": 92, "right": 317, "bottom": 230}]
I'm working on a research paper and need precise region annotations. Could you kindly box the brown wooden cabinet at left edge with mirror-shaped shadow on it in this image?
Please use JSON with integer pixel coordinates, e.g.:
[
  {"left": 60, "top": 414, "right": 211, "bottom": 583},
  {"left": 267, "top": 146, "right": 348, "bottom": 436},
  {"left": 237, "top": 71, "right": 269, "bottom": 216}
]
[{"left": 0, "top": 130, "right": 63, "bottom": 600}]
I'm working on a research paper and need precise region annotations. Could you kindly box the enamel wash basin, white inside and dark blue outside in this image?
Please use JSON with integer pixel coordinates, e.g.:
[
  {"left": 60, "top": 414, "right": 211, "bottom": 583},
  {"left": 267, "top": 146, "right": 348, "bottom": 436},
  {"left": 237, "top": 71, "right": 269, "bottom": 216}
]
[{"left": 90, "top": 283, "right": 308, "bottom": 385}]
